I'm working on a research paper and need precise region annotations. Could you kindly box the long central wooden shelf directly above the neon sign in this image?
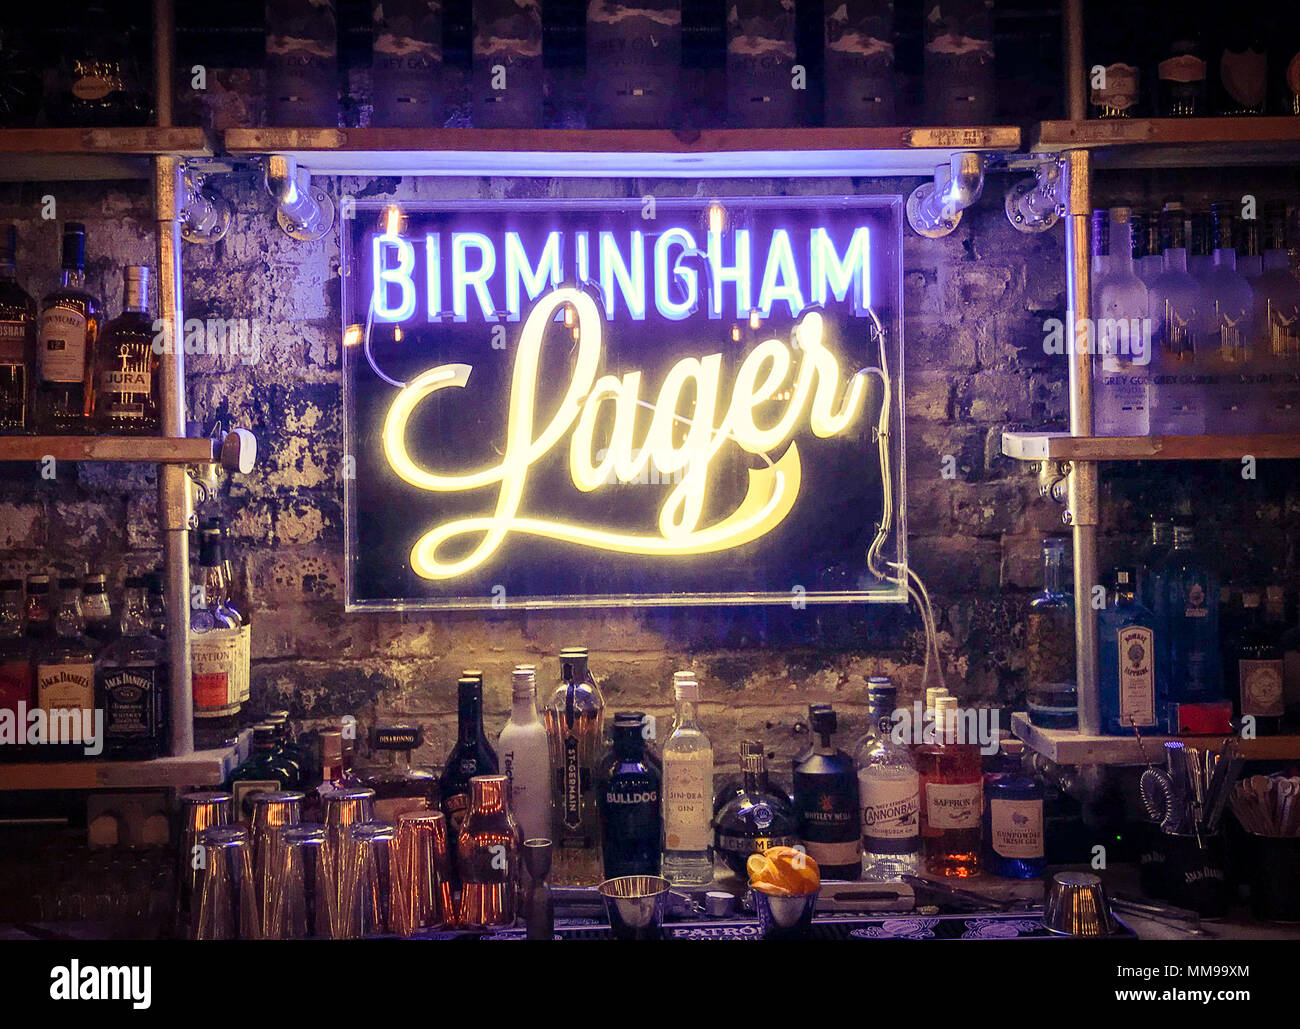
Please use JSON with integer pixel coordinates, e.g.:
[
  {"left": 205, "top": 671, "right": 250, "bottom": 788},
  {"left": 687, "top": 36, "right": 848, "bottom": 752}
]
[{"left": 225, "top": 126, "right": 1021, "bottom": 178}]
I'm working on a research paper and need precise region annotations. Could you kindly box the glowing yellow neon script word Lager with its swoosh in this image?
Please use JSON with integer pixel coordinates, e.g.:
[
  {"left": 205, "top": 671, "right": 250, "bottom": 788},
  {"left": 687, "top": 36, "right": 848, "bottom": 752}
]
[{"left": 384, "top": 288, "right": 867, "bottom": 579}]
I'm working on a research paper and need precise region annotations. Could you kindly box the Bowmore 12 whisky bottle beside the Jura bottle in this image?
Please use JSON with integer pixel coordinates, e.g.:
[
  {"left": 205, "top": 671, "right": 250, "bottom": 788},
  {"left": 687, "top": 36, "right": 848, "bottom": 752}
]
[{"left": 36, "top": 222, "right": 100, "bottom": 433}]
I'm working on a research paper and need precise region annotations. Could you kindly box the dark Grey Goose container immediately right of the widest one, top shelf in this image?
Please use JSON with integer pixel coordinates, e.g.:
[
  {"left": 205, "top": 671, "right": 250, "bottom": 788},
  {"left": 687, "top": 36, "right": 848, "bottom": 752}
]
[{"left": 728, "top": 0, "right": 801, "bottom": 129}]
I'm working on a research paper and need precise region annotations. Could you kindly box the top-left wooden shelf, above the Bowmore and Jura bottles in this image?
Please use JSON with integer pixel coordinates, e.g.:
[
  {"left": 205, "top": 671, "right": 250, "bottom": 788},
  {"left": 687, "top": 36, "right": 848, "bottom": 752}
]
[{"left": 0, "top": 127, "right": 213, "bottom": 182}]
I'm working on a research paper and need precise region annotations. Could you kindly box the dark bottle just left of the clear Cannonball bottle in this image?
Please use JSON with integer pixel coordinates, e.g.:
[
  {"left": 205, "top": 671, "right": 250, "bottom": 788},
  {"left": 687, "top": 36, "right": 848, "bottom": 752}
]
[{"left": 794, "top": 704, "right": 862, "bottom": 880}]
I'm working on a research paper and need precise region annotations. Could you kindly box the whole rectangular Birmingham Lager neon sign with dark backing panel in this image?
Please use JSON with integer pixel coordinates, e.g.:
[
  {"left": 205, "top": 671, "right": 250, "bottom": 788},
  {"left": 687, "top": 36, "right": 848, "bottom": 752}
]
[{"left": 343, "top": 197, "right": 906, "bottom": 609}]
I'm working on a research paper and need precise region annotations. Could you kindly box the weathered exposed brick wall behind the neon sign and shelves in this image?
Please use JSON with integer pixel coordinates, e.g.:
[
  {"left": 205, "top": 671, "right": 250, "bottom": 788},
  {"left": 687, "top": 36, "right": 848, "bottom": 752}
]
[{"left": 0, "top": 170, "right": 1300, "bottom": 768}]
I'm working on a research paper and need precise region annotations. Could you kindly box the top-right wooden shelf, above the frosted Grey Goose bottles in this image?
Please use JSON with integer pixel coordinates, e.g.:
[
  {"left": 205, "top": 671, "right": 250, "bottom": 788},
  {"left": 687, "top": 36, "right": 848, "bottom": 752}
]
[{"left": 1028, "top": 117, "right": 1300, "bottom": 168}]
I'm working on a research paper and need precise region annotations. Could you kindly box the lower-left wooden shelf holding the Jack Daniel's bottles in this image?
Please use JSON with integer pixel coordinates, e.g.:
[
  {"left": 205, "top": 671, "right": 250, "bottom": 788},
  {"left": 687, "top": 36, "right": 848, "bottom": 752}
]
[{"left": 0, "top": 747, "right": 238, "bottom": 790}]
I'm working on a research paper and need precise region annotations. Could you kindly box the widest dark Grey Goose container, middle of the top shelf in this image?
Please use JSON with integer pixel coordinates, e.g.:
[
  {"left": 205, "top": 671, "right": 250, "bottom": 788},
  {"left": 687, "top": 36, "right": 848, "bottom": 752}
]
[{"left": 586, "top": 0, "right": 681, "bottom": 129}]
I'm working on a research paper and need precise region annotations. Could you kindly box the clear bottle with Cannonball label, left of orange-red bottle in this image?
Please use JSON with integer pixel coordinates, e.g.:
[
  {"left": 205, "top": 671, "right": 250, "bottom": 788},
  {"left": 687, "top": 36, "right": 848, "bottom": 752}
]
[{"left": 854, "top": 676, "right": 920, "bottom": 882}]
